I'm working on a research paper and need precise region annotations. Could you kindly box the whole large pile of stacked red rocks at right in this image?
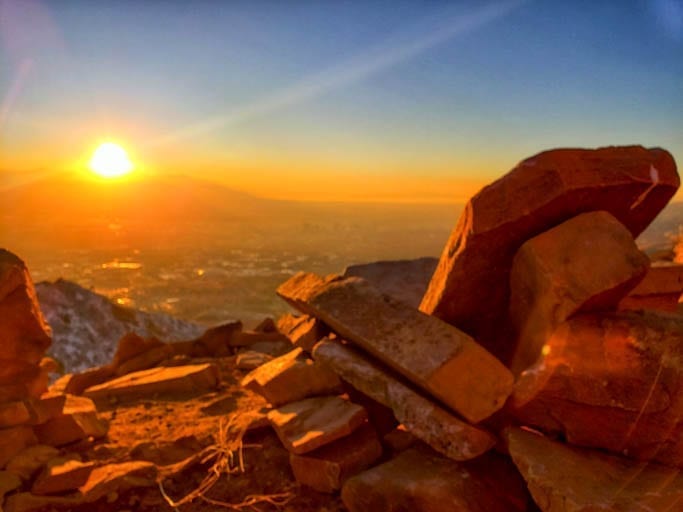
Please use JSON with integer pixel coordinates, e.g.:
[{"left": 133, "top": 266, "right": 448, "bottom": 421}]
[{"left": 243, "top": 147, "right": 683, "bottom": 512}]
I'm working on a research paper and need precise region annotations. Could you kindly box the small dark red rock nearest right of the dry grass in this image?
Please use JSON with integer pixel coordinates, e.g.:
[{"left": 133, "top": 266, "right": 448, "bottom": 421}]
[{"left": 289, "top": 425, "right": 382, "bottom": 493}]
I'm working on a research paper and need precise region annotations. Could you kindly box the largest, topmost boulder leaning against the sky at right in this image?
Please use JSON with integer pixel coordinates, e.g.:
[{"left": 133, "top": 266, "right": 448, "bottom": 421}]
[{"left": 420, "top": 146, "right": 679, "bottom": 354}]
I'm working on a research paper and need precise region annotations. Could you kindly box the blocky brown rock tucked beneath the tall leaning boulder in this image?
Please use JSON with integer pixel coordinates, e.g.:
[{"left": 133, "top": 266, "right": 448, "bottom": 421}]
[{"left": 510, "top": 212, "right": 650, "bottom": 375}]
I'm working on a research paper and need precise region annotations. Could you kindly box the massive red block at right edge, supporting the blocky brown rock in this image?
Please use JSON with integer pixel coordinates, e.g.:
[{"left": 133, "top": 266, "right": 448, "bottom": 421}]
[{"left": 509, "top": 312, "right": 683, "bottom": 467}]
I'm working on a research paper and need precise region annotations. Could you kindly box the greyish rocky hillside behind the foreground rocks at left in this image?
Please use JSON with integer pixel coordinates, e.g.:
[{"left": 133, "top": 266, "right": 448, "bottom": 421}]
[{"left": 35, "top": 279, "right": 204, "bottom": 372}]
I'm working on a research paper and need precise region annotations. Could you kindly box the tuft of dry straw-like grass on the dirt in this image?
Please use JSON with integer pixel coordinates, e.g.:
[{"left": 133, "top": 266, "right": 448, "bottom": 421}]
[{"left": 157, "top": 416, "right": 294, "bottom": 511}]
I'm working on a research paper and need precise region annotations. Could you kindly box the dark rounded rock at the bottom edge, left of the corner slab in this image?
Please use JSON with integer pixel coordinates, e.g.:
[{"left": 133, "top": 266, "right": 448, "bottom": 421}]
[{"left": 341, "top": 449, "right": 528, "bottom": 512}]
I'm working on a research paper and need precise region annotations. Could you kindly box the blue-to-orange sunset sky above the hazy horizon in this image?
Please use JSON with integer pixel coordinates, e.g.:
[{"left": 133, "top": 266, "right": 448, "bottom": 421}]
[{"left": 0, "top": 0, "right": 683, "bottom": 201}]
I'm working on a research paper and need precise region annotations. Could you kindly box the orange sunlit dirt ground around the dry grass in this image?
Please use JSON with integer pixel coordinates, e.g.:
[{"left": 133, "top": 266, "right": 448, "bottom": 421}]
[{"left": 64, "top": 357, "right": 345, "bottom": 512}]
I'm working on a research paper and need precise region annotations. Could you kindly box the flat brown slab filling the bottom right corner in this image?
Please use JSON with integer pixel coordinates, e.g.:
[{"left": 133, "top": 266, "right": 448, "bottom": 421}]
[{"left": 505, "top": 429, "right": 683, "bottom": 512}]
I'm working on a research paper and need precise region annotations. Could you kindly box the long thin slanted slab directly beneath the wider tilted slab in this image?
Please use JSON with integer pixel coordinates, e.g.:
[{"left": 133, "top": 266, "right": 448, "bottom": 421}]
[{"left": 313, "top": 340, "right": 496, "bottom": 460}]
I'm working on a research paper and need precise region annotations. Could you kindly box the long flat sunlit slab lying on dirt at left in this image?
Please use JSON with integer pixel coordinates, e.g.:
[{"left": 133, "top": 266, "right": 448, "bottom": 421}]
[{"left": 83, "top": 363, "right": 220, "bottom": 400}]
